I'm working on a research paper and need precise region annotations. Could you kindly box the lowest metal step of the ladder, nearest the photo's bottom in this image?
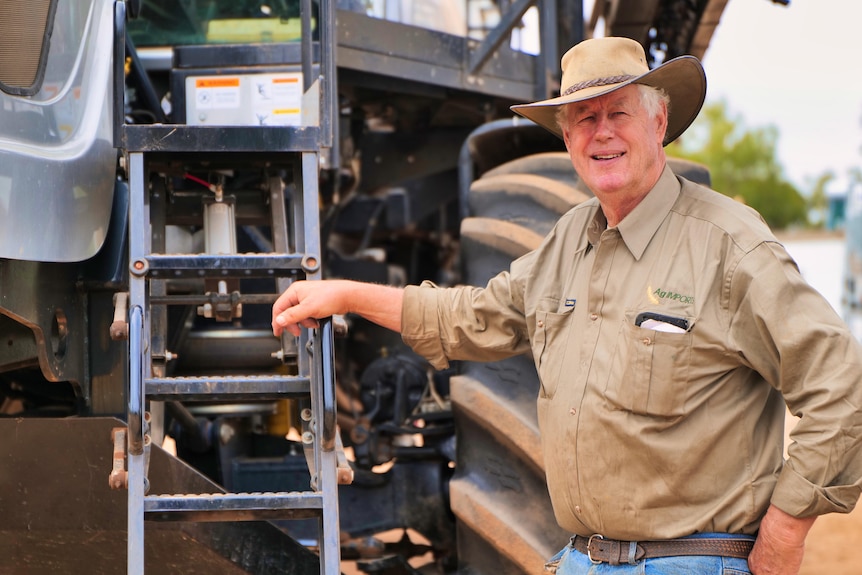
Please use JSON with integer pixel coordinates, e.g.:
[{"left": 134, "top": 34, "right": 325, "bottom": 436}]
[{"left": 144, "top": 491, "right": 323, "bottom": 522}]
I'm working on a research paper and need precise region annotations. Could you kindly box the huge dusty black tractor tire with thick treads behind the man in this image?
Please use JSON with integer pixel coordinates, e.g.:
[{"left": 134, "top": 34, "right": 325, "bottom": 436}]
[{"left": 450, "top": 152, "right": 709, "bottom": 575}]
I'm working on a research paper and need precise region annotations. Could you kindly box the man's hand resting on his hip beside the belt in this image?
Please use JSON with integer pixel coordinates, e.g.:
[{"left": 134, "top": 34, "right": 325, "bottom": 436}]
[{"left": 748, "top": 505, "right": 816, "bottom": 575}]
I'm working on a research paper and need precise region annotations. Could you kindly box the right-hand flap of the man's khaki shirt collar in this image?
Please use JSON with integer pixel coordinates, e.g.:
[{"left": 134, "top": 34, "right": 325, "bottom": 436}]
[{"left": 616, "top": 165, "right": 681, "bottom": 260}]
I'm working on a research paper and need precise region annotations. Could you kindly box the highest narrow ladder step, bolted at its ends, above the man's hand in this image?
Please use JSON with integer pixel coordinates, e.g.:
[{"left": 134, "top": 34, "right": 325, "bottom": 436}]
[{"left": 143, "top": 253, "right": 316, "bottom": 279}]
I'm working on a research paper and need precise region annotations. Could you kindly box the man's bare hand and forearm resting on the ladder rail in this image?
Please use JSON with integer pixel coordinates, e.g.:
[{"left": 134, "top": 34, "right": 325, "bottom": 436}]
[{"left": 272, "top": 280, "right": 404, "bottom": 336}]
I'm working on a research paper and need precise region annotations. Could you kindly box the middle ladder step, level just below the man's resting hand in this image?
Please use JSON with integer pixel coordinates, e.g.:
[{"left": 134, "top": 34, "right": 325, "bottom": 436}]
[{"left": 144, "top": 375, "right": 311, "bottom": 401}]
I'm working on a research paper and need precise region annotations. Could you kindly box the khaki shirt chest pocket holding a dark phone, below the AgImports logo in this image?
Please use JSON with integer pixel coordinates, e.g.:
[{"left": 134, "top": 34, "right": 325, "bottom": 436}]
[{"left": 605, "top": 318, "right": 694, "bottom": 418}]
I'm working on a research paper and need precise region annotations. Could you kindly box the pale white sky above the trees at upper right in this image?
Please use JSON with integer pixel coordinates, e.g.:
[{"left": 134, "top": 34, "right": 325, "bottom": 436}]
[{"left": 584, "top": 0, "right": 862, "bottom": 193}]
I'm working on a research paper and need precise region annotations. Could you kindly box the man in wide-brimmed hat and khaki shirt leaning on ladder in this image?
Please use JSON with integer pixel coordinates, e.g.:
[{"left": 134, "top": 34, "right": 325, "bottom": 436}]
[{"left": 273, "top": 38, "right": 862, "bottom": 575}]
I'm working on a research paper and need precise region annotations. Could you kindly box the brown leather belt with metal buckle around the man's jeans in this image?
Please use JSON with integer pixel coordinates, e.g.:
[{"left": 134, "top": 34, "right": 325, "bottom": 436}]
[{"left": 572, "top": 535, "right": 754, "bottom": 565}]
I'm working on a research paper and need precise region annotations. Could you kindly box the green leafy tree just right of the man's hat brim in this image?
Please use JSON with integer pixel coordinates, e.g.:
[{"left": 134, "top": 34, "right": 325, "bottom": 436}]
[{"left": 667, "top": 101, "right": 808, "bottom": 229}]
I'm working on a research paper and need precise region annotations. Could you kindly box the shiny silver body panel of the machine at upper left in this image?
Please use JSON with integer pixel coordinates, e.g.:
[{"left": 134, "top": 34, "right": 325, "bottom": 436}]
[{"left": 0, "top": 0, "right": 117, "bottom": 262}]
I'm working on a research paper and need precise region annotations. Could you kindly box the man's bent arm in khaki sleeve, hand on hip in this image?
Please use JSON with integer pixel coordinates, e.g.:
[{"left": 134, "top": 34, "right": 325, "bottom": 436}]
[{"left": 728, "top": 242, "right": 862, "bottom": 575}]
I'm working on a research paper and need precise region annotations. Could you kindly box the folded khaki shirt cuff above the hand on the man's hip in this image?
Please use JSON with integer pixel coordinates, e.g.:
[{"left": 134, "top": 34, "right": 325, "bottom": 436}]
[{"left": 772, "top": 462, "right": 860, "bottom": 518}]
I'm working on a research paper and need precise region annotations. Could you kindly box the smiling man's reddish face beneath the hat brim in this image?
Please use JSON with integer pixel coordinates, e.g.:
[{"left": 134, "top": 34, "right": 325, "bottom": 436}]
[{"left": 562, "top": 85, "right": 667, "bottom": 209}]
